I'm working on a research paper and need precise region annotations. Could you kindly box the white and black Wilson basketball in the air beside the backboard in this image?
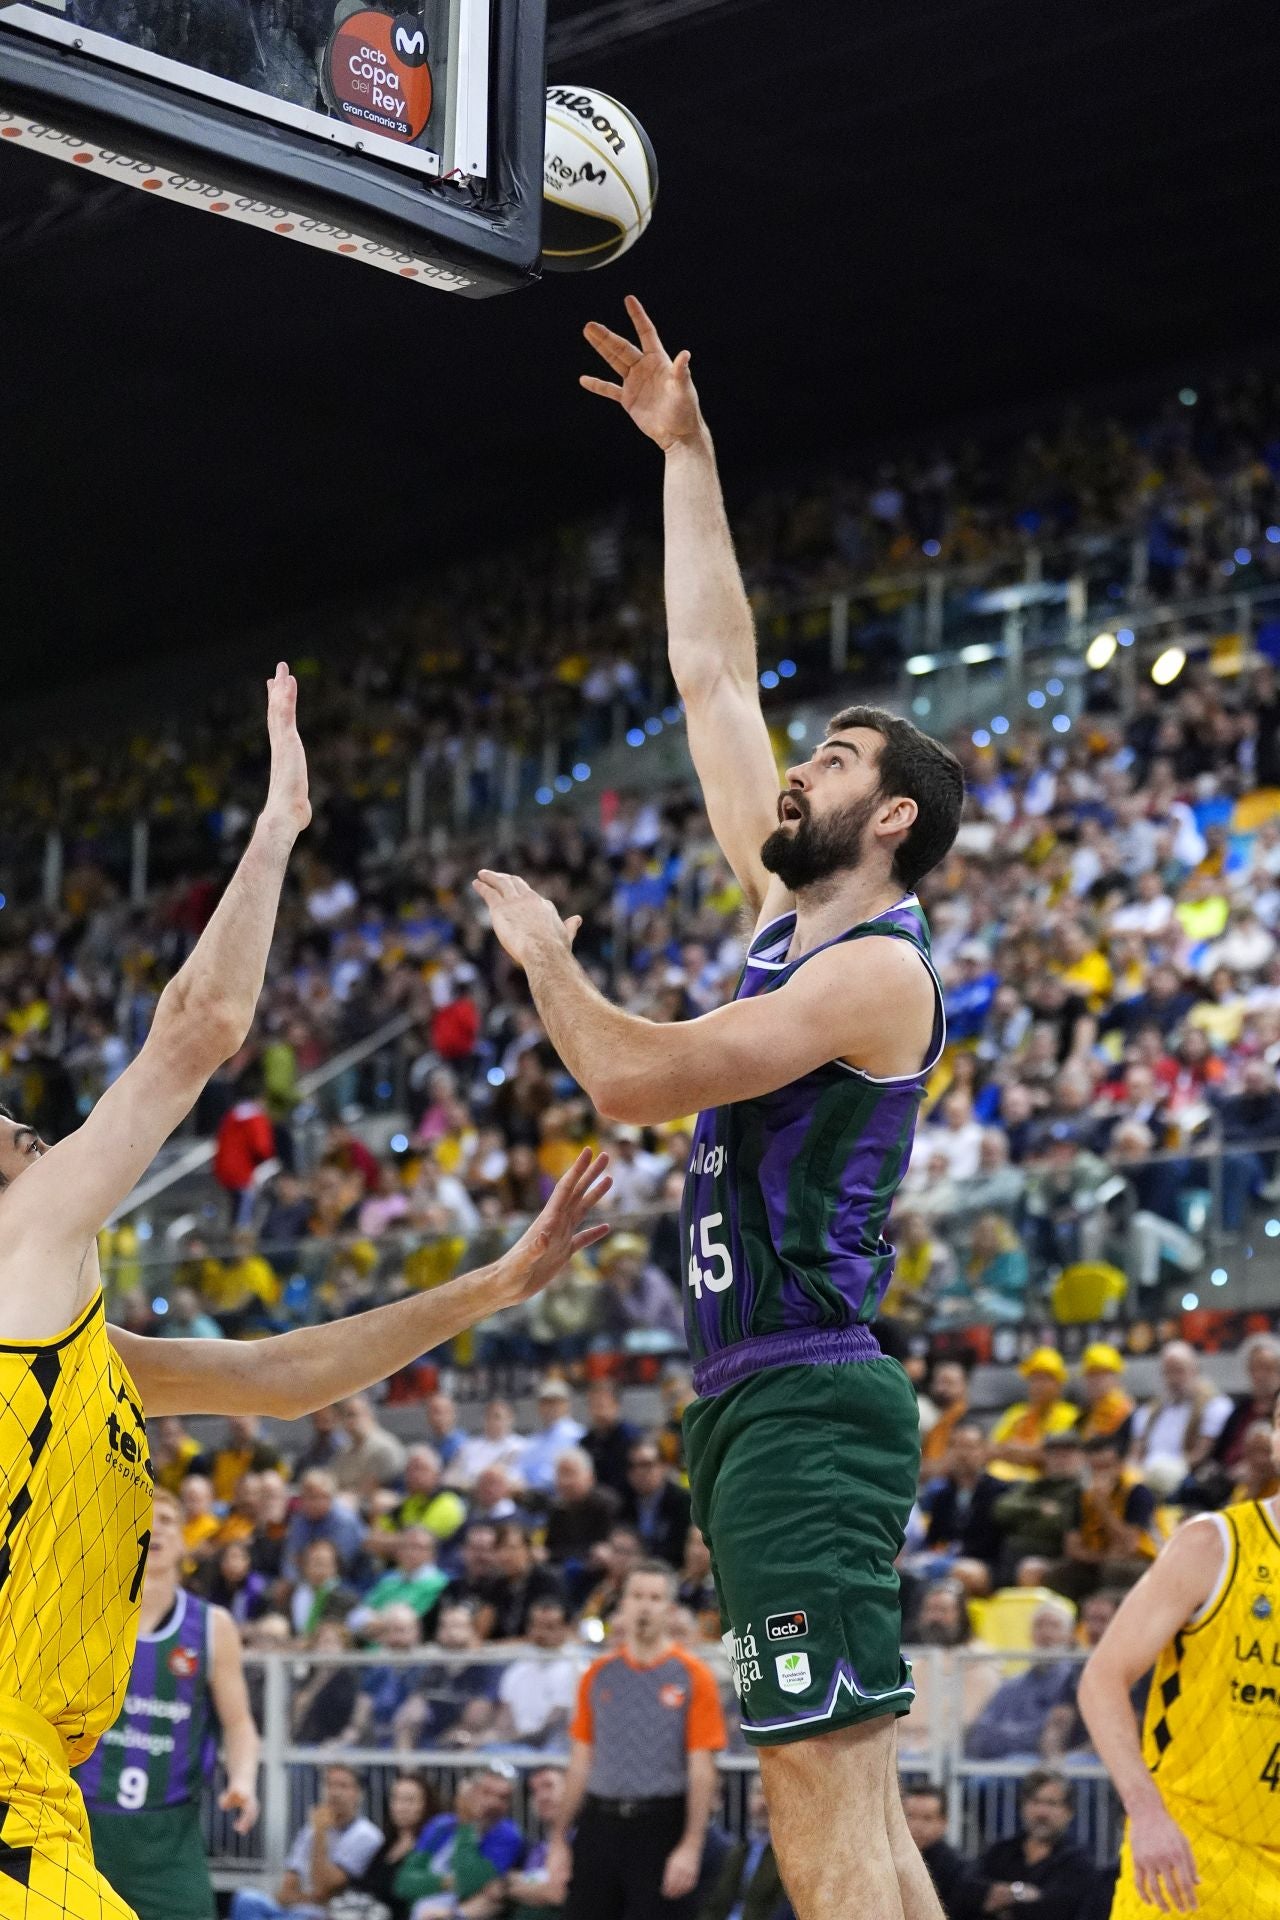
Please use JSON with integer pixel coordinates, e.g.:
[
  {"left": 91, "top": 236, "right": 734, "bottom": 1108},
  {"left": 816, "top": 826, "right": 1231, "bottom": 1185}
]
[{"left": 543, "top": 86, "right": 658, "bottom": 273}]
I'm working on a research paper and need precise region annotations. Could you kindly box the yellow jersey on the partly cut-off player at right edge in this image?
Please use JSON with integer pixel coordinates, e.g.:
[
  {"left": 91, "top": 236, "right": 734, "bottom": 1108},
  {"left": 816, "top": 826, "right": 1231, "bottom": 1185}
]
[{"left": 1142, "top": 1501, "right": 1280, "bottom": 1847}]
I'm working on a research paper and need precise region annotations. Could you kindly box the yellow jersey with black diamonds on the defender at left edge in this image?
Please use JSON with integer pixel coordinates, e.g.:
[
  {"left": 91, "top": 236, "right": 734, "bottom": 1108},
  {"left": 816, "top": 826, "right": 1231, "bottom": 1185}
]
[{"left": 0, "top": 1292, "right": 154, "bottom": 1766}]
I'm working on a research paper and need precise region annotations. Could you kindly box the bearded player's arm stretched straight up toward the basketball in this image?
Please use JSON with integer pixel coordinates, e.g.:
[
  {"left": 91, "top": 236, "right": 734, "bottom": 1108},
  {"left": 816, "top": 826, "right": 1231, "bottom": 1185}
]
[{"left": 581, "top": 298, "right": 787, "bottom": 914}]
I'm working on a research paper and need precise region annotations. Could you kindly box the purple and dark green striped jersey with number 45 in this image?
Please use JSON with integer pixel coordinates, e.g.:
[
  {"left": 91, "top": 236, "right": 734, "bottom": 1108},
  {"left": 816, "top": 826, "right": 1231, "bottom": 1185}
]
[{"left": 681, "top": 893, "right": 946, "bottom": 1394}]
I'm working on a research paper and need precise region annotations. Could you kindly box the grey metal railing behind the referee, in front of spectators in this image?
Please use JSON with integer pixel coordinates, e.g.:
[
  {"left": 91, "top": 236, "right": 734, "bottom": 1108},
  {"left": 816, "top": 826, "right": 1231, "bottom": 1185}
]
[{"left": 189, "top": 1642, "right": 1123, "bottom": 1887}]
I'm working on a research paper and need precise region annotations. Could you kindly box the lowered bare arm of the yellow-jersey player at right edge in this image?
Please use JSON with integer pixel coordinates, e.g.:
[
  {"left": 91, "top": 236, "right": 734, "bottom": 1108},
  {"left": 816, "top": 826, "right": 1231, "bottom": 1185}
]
[{"left": 1079, "top": 1515, "right": 1224, "bottom": 1912}]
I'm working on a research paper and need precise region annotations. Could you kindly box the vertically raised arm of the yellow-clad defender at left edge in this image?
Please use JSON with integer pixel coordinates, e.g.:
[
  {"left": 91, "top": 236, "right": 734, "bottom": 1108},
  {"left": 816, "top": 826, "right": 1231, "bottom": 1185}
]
[{"left": 0, "top": 662, "right": 311, "bottom": 1340}]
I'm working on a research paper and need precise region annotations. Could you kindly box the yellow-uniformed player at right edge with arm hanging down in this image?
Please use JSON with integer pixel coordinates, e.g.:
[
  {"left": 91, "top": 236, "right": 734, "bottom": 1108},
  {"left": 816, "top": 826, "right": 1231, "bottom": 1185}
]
[{"left": 1080, "top": 1415, "right": 1280, "bottom": 1920}]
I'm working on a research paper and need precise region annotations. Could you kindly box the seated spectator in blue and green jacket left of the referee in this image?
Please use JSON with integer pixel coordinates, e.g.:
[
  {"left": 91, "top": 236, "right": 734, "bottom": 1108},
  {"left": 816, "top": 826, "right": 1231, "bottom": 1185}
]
[{"left": 397, "top": 1761, "right": 524, "bottom": 1920}]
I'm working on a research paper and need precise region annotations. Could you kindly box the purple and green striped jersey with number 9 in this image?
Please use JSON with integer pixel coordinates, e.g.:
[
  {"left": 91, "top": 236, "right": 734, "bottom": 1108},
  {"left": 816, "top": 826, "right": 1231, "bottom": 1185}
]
[{"left": 75, "top": 1590, "right": 217, "bottom": 1814}]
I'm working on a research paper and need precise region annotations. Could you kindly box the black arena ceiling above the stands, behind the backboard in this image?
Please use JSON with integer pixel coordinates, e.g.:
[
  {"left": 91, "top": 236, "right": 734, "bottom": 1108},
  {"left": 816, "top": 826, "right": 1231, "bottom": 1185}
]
[{"left": 0, "top": 0, "right": 1280, "bottom": 699}]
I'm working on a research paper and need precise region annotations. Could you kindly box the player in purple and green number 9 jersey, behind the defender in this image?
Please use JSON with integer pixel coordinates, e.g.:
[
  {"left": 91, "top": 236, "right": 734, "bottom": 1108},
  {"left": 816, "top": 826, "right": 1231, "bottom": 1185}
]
[{"left": 75, "top": 1486, "right": 261, "bottom": 1920}]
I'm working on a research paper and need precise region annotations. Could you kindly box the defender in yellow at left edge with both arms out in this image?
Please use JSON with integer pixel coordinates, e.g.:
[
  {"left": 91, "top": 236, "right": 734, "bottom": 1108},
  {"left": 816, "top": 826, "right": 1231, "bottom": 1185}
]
[{"left": 0, "top": 664, "right": 608, "bottom": 1920}]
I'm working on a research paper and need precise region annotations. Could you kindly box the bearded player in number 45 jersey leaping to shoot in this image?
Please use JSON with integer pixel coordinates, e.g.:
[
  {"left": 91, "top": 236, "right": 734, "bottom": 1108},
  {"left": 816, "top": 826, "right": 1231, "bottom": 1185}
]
[{"left": 476, "top": 301, "right": 963, "bottom": 1920}]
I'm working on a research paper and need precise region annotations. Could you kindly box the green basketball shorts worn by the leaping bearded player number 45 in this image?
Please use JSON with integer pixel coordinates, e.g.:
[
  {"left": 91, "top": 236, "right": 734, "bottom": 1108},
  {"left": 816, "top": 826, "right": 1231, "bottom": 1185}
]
[{"left": 685, "top": 1356, "right": 919, "bottom": 1747}]
